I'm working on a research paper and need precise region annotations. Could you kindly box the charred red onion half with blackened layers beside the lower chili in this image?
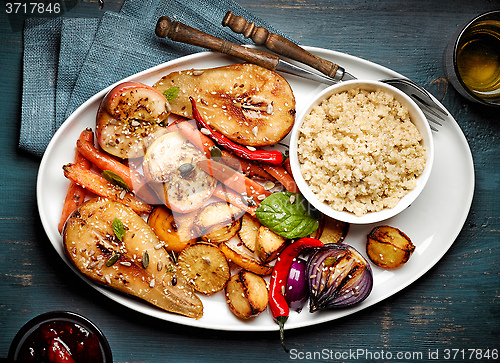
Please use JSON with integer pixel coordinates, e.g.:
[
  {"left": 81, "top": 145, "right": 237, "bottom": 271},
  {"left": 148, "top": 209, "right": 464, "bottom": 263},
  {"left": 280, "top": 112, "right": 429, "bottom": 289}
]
[{"left": 307, "top": 244, "right": 373, "bottom": 312}]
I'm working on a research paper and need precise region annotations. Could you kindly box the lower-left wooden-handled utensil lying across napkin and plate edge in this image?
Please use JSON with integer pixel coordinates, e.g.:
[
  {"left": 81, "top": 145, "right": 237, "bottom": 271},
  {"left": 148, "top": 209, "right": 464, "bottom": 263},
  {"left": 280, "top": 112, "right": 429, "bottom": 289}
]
[{"left": 155, "top": 16, "right": 354, "bottom": 84}]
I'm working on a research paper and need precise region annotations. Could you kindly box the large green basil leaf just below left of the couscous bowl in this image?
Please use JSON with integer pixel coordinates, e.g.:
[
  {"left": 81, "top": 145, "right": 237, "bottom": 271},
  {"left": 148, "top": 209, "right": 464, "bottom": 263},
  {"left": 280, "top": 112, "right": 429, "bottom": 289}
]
[{"left": 255, "top": 192, "right": 319, "bottom": 239}]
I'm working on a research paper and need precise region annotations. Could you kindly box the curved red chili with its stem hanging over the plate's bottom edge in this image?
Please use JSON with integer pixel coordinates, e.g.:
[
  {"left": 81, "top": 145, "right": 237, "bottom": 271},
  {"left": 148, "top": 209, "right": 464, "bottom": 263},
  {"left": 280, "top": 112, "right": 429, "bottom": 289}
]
[{"left": 269, "top": 237, "right": 324, "bottom": 351}]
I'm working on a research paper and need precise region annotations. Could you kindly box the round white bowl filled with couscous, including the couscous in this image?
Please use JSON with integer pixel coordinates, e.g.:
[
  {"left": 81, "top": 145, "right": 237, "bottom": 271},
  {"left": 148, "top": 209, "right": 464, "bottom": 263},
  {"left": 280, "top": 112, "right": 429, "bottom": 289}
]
[{"left": 290, "top": 80, "right": 434, "bottom": 224}]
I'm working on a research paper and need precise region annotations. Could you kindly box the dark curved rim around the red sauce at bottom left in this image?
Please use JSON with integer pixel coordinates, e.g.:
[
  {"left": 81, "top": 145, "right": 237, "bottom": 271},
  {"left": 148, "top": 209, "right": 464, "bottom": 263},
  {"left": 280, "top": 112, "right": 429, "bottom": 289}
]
[{"left": 8, "top": 310, "right": 113, "bottom": 363}]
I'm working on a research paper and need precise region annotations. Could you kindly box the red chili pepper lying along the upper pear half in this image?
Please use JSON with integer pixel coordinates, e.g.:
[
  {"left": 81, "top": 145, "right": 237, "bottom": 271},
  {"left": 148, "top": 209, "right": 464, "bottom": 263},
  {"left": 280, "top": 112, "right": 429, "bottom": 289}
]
[{"left": 189, "top": 97, "right": 286, "bottom": 164}]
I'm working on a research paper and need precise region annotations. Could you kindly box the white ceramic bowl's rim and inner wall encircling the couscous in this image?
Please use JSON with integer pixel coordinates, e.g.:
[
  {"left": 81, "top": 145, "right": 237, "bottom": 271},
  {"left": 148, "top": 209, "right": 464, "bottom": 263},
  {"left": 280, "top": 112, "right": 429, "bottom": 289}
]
[{"left": 290, "top": 80, "right": 434, "bottom": 224}]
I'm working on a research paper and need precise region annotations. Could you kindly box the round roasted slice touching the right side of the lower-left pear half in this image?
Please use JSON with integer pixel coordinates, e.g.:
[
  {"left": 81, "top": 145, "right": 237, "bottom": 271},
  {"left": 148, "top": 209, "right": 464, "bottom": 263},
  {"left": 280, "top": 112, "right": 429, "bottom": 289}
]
[{"left": 177, "top": 243, "right": 231, "bottom": 295}]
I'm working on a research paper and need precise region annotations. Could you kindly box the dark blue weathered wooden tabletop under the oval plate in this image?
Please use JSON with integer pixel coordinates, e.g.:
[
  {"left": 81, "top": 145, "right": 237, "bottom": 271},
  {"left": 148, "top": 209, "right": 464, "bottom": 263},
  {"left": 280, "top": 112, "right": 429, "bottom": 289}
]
[{"left": 0, "top": 0, "right": 500, "bottom": 362}]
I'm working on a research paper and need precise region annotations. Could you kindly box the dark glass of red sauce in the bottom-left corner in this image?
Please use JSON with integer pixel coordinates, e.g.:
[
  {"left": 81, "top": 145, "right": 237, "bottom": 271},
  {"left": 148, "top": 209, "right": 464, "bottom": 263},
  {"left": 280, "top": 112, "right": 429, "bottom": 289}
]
[{"left": 9, "top": 311, "right": 113, "bottom": 363}]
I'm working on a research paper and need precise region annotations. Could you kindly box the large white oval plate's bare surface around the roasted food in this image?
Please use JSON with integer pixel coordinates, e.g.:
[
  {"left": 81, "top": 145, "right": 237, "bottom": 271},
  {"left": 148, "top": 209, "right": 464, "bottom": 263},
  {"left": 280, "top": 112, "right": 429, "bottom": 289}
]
[{"left": 37, "top": 47, "right": 474, "bottom": 331}]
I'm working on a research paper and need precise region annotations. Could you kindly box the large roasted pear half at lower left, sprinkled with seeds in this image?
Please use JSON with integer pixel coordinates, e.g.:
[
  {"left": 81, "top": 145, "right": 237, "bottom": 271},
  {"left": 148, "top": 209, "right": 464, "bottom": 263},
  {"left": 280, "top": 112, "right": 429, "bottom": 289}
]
[{"left": 63, "top": 198, "right": 203, "bottom": 319}]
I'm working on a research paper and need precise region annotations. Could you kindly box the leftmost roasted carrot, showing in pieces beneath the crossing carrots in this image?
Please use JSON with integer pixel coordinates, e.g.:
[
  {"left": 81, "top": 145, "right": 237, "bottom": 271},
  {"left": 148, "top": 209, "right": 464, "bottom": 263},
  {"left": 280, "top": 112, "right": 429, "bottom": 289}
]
[{"left": 57, "top": 129, "right": 94, "bottom": 233}]
